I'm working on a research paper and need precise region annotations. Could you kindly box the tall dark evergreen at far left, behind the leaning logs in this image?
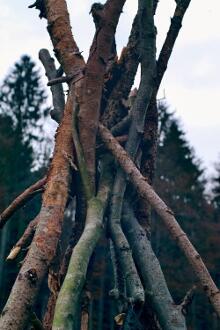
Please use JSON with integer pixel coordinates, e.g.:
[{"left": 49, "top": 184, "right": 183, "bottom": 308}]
[{"left": 0, "top": 55, "right": 49, "bottom": 308}]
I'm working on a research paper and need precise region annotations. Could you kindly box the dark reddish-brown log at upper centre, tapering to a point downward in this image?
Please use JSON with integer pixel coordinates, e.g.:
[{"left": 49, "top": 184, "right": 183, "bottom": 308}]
[{"left": 78, "top": 0, "right": 125, "bottom": 193}]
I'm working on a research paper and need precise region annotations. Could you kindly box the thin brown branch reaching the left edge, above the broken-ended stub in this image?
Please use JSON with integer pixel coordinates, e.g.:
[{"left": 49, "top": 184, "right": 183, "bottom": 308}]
[{"left": 0, "top": 176, "right": 47, "bottom": 228}]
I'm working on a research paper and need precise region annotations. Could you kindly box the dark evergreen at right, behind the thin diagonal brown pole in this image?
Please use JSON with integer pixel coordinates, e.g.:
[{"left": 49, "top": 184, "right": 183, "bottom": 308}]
[{"left": 152, "top": 104, "right": 215, "bottom": 329}]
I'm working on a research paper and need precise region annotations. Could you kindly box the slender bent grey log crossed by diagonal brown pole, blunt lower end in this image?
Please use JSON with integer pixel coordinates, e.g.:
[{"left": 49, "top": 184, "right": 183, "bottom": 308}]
[{"left": 109, "top": 1, "right": 156, "bottom": 302}]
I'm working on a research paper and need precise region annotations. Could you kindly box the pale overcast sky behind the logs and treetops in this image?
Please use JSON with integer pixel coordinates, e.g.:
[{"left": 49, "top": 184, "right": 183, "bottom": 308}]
[{"left": 0, "top": 0, "right": 220, "bottom": 178}]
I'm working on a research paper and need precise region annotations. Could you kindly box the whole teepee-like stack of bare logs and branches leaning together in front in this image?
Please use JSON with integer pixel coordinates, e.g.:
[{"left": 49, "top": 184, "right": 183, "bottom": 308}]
[{"left": 0, "top": 0, "right": 220, "bottom": 330}]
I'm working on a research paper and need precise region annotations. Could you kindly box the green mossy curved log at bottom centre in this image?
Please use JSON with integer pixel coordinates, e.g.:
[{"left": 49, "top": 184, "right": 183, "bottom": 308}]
[{"left": 53, "top": 156, "right": 112, "bottom": 330}]
